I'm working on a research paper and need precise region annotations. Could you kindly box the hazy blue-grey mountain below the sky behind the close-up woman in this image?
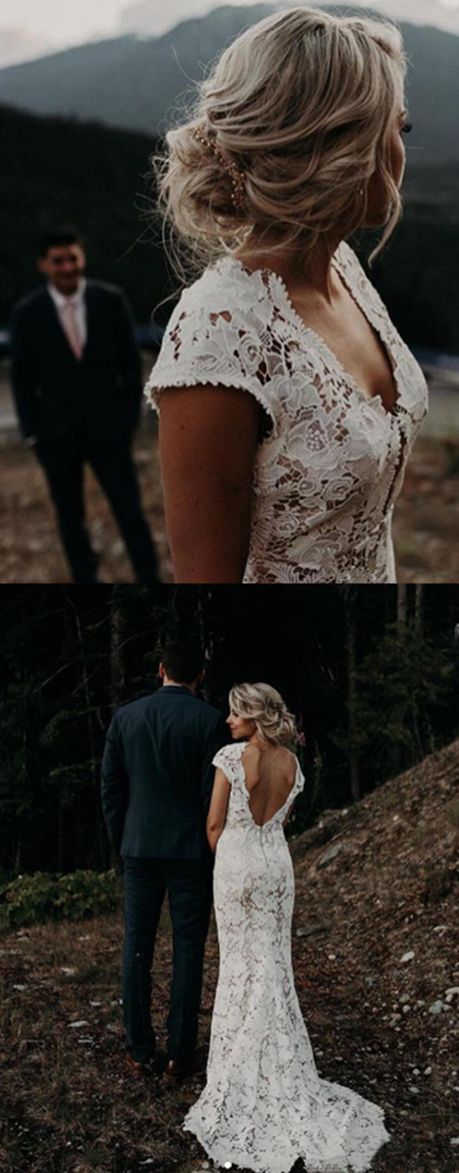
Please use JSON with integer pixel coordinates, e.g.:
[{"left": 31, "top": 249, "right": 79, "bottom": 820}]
[{"left": 0, "top": 4, "right": 459, "bottom": 164}]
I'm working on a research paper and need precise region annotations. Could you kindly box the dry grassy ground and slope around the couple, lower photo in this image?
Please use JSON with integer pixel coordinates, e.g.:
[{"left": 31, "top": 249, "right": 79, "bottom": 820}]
[{"left": 0, "top": 741, "right": 459, "bottom": 1173}]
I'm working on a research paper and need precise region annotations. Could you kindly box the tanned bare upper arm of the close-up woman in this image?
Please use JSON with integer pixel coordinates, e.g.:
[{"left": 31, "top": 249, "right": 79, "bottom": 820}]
[{"left": 160, "top": 386, "right": 259, "bottom": 583}]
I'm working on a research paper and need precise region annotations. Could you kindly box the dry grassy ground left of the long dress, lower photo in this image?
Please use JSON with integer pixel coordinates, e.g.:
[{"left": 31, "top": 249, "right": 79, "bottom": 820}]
[{"left": 0, "top": 917, "right": 205, "bottom": 1173}]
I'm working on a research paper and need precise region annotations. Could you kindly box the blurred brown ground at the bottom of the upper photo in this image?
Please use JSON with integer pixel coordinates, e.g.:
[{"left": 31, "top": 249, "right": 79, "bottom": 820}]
[{"left": 0, "top": 422, "right": 459, "bottom": 583}]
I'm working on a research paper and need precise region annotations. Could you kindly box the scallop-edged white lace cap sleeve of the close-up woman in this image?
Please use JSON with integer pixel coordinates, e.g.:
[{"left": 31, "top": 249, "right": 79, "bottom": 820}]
[{"left": 144, "top": 271, "right": 277, "bottom": 429}]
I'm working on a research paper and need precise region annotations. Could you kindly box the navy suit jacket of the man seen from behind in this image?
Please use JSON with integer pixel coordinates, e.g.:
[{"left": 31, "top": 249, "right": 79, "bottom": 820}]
[{"left": 102, "top": 685, "right": 228, "bottom": 860}]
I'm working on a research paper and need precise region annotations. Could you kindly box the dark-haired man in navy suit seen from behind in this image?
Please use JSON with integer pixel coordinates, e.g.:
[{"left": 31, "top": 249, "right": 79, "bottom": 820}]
[{"left": 102, "top": 642, "right": 228, "bottom": 1079}]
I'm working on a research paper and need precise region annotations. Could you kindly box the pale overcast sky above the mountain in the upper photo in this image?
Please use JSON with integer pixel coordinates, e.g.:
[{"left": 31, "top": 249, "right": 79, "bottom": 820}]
[{"left": 0, "top": 0, "right": 459, "bottom": 56}]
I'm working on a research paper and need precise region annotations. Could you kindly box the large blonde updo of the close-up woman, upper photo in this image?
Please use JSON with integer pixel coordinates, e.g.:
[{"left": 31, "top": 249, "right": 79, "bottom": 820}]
[{"left": 153, "top": 8, "right": 406, "bottom": 264}]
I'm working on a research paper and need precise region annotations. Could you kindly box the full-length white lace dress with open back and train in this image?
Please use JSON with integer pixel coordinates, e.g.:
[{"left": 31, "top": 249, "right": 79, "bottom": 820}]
[{"left": 184, "top": 743, "right": 389, "bottom": 1173}]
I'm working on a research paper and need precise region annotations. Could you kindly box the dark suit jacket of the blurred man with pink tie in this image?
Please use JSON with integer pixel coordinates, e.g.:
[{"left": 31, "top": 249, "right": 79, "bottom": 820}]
[{"left": 12, "top": 280, "right": 142, "bottom": 449}]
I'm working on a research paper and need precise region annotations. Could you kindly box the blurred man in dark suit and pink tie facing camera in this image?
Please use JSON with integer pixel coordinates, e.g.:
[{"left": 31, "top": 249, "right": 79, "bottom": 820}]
[{"left": 12, "top": 228, "right": 158, "bottom": 585}]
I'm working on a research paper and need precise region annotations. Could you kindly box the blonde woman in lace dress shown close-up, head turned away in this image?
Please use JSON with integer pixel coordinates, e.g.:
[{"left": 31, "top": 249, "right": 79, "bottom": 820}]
[{"left": 146, "top": 8, "right": 426, "bottom": 583}]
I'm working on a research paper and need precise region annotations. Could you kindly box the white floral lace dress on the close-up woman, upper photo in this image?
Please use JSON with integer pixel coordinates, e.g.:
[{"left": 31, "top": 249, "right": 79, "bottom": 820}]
[{"left": 146, "top": 244, "right": 427, "bottom": 583}]
